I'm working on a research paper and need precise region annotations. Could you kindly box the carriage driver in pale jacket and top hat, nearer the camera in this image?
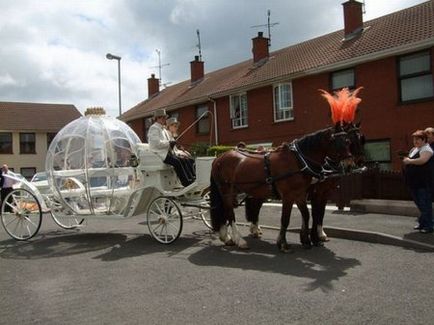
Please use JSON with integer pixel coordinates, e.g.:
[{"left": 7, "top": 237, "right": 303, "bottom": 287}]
[{"left": 148, "top": 109, "right": 194, "bottom": 186}]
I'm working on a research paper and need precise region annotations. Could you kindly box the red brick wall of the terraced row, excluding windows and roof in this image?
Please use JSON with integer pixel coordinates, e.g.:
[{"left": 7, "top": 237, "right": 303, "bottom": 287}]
[{"left": 127, "top": 48, "right": 434, "bottom": 170}]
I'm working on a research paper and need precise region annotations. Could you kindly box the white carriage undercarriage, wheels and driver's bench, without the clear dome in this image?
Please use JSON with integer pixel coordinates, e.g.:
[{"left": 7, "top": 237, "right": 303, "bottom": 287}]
[{"left": 1, "top": 143, "right": 214, "bottom": 244}]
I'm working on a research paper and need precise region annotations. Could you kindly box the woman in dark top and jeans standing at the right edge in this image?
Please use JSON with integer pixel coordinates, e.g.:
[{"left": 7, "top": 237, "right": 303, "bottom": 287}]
[{"left": 402, "top": 130, "right": 433, "bottom": 234}]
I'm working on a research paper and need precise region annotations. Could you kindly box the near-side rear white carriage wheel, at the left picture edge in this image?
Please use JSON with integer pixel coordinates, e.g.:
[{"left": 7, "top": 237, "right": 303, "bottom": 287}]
[{"left": 1, "top": 188, "right": 42, "bottom": 240}]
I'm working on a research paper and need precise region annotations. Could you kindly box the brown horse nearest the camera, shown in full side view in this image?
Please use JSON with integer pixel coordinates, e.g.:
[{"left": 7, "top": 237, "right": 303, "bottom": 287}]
[{"left": 210, "top": 124, "right": 351, "bottom": 251}]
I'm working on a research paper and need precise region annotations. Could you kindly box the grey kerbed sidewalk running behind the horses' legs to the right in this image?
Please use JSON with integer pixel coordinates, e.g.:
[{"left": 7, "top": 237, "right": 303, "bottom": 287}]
[{"left": 237, "top": 203, "right": 434, "bottom": 252}]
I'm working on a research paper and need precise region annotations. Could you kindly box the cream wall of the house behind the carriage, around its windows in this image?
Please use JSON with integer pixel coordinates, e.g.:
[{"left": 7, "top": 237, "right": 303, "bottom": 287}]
[{"left": 0, "top": 131, "right": 48, "bottom": 173}]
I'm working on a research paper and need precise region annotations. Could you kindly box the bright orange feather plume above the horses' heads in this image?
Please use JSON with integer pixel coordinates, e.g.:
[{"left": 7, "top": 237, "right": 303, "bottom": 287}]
[{"left": 319, "top": 87, "right": 363, "bottom": 124}]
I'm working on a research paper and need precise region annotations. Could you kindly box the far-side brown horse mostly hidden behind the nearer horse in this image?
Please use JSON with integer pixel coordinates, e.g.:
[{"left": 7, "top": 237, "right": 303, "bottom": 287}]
[{"left": 245, "top": 123, "right": 364, "bottom": 248}]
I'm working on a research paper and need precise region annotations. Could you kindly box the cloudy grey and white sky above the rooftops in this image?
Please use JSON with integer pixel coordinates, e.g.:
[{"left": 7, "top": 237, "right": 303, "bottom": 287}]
[{"left": 0, "top": 0, "right": 426, "bottom": 117}]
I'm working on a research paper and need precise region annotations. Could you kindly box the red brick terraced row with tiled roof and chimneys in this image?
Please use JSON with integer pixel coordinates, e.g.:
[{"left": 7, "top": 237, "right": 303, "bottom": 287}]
[{"left": 122, "top": 0, "right": 434, "bottom": 169}]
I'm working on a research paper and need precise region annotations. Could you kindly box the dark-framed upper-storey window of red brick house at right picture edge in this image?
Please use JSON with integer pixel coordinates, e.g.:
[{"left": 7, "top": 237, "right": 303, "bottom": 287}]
[{"left": 399, "top": 51, "right": 434, "bottom": 102}]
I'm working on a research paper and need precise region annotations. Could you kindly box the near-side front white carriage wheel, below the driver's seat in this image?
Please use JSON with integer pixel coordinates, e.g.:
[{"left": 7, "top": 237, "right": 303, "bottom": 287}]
[{"left": 147, "top": 196, "right": 182, "bottom": 244}]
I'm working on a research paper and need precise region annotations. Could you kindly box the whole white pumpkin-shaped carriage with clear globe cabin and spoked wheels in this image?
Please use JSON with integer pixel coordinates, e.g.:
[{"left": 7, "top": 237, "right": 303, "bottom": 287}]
[{"left": 1, "top": 109, "right": 214, "bottom": 244}]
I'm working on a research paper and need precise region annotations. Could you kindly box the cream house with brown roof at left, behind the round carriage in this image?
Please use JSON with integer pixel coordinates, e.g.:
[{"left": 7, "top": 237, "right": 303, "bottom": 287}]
[{"left": 0, "top": 102, "right": 81, "bottom": 179}]
